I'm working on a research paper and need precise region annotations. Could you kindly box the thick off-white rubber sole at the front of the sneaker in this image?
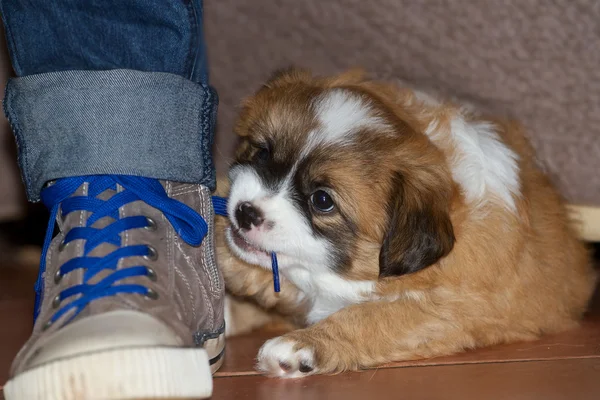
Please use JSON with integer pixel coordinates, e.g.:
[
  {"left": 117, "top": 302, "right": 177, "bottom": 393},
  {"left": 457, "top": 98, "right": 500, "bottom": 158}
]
[{"left": 4, "top": 335, "right": 225, "bottom": 400}]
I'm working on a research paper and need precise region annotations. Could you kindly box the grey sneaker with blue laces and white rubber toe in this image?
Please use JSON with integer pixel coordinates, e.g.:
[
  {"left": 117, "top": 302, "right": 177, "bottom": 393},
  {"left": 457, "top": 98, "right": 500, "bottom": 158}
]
[{"left": 4, "top": 176, "right": 225, "bottom": 400}]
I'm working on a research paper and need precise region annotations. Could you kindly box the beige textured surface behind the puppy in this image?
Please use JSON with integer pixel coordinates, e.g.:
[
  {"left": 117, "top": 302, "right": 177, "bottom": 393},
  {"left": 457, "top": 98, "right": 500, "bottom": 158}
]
[{"left": 205, "top": 0, "right": 600, "bottom": 206}]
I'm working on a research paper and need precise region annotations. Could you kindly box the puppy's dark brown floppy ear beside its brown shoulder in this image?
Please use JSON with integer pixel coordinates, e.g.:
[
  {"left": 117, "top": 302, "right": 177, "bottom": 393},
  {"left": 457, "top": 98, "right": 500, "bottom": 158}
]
[{"left": 379, "top": 174, "right": 455, "bottom": 277}]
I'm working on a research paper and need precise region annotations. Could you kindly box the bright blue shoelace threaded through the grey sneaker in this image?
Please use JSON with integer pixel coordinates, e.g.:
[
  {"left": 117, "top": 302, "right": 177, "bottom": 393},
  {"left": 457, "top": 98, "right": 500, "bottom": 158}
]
[{"left": 34, "top": 175, "right": 233, "bottom": 325}]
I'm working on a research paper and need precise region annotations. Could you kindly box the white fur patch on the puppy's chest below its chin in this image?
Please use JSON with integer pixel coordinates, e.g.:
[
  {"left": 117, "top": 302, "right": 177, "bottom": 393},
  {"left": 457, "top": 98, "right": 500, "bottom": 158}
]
[{"left": 285, "top": 267, "right": 375, "bottom": 324}]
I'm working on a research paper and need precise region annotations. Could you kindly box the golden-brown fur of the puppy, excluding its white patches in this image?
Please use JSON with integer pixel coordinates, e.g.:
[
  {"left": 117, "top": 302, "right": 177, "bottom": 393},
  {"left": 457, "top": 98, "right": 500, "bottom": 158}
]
[{"left": 217, "top": 71, "right": 595, "bottom": 373}]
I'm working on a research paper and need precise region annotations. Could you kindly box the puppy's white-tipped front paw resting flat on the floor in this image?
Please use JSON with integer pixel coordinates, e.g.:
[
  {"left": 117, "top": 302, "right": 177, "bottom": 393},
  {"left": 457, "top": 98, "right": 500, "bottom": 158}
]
[{"left": 256, "top": 336, "right": 317, "bottom": 378}]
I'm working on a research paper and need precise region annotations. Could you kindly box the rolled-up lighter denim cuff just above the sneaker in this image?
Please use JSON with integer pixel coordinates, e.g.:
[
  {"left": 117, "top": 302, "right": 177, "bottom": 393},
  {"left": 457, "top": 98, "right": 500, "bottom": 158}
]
[{"left": 4, "top": 70, "right": 218, "bottom": 201}]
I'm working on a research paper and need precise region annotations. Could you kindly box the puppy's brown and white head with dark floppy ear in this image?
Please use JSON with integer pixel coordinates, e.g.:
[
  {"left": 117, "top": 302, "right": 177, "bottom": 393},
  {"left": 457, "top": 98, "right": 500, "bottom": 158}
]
[{"left": 227, "top": 70, "right": 454, "bottom": 279}]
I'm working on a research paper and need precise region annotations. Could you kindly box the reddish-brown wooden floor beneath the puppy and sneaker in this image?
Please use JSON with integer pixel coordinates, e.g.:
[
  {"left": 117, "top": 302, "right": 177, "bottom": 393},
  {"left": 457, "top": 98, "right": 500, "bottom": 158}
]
[{"left": 0, "top": 258, "right": 600, "bottom": 400}]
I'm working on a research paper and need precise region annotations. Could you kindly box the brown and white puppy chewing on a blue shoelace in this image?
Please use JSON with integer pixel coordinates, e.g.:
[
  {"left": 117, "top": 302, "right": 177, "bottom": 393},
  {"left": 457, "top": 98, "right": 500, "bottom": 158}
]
[{"left": 219, "top": 70, "right": 595, "bottom": 377}]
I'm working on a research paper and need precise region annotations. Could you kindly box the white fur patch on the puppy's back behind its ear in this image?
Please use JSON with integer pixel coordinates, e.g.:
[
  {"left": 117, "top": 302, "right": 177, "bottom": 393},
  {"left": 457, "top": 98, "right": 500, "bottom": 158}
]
[{"left": 426, "top": 110, "right": 520, "bottom": 211}]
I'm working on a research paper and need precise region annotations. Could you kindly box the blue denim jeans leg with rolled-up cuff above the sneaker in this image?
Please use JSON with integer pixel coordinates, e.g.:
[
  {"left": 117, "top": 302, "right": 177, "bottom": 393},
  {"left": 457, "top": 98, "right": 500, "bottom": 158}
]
[{"left": 0, "top": 0, "right": 217, "bottom": 201}]
